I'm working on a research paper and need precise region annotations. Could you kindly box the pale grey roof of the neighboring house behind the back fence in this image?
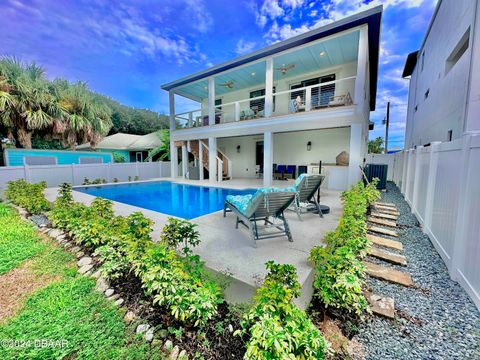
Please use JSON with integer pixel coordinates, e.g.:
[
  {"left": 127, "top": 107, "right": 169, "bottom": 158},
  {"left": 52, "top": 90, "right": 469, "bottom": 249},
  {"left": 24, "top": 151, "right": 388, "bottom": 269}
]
[{"left": 77, "top": 132, "right": 162, "bottom": 150}]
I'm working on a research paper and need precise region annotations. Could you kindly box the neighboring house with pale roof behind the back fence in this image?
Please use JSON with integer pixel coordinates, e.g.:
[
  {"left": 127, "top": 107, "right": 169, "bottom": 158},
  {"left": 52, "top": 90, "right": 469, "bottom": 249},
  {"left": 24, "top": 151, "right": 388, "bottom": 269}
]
[{"left": 77, "top": 132, "right": 162, "bottom": 162}]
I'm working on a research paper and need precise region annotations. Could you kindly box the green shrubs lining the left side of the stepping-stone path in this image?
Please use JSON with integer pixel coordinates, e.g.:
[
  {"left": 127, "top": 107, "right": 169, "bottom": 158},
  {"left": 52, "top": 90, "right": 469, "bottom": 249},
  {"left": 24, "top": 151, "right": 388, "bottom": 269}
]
[{"left": 310, "top": 180, "right": 380, "bottom": 315}]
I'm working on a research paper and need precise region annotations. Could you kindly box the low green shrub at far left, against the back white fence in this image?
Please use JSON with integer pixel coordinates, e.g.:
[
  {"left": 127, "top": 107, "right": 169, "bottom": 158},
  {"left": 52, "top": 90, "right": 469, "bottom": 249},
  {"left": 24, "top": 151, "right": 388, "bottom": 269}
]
[{"left": 5, "top": 179, "right": 51, "bottom": 215}]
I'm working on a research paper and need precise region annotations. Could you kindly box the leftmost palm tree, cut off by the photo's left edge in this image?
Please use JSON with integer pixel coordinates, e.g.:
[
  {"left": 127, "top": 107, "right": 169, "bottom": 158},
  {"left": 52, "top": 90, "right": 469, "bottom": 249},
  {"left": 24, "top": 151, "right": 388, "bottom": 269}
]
[{"left": 0, "top": 58, "right": 65, "bottom": 149}]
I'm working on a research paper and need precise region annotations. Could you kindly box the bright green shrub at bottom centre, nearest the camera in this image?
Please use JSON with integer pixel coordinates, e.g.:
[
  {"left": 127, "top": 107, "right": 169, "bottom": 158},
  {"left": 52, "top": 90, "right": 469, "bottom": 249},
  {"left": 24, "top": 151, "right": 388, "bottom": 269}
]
[{"left": 236, "top": 261, "right": 330, "bottom": 360}]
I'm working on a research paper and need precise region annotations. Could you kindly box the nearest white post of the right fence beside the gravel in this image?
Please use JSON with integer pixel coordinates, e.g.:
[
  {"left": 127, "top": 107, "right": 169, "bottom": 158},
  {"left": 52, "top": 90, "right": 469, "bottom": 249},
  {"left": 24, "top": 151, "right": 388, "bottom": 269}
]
[{"left": 449, "top": 135, "right": 473, "bottom": 280}]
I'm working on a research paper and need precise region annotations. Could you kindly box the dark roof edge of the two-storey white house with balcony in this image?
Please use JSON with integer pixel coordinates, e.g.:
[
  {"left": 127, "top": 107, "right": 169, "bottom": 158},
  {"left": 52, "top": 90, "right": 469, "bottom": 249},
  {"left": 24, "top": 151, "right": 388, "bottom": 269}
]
[{"left": 161, "top": 5, "right": 383, "bottom": 111}]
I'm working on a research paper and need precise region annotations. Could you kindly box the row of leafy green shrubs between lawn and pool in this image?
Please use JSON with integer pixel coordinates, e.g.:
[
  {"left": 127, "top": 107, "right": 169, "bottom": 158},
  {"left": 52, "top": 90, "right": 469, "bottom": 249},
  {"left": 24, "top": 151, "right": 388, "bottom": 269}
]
[{"left": 51, "top": 186, "right": 222, "bottom": 325}]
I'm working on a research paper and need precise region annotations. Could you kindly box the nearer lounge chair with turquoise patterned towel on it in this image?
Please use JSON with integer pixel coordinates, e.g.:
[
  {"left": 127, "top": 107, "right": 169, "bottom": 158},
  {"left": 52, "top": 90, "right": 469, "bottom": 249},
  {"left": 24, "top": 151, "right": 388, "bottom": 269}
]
[{"left": 223, "top": 188, "right": 296, "bottom": 247}]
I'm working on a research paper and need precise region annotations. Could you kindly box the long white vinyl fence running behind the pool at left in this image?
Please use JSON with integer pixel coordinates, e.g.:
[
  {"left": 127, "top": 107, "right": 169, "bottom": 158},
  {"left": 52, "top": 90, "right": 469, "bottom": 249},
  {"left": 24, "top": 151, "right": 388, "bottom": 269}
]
[{"left": 0, "top": 161, "right": 170, "bottom": 189}]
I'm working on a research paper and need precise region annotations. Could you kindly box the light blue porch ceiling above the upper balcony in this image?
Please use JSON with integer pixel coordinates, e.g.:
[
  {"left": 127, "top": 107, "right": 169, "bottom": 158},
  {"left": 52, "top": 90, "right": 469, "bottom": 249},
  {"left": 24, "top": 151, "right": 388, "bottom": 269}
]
[{"left": 175, "top": 31, "right": 359, "bottom": 101}]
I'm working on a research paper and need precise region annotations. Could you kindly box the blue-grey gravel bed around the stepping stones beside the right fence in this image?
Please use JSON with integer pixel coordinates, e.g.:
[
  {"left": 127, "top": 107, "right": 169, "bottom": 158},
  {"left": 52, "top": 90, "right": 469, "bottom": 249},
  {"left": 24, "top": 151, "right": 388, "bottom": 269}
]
[{"left": 355, "top": 182, "right": 480, "bottom": 359}]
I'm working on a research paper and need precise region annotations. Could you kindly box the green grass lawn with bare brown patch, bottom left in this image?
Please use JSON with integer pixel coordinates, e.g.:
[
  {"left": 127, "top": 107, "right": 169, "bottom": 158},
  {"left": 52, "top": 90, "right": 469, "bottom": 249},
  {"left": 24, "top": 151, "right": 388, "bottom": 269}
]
[{"left": 0, "top": 203, "right": 162, "bottom": 359}]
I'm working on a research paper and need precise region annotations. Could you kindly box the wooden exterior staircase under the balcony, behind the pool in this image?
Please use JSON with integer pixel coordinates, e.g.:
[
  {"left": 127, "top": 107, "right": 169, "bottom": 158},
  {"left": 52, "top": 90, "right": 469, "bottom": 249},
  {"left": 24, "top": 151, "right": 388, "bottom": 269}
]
[{"left": 187, "top": 140, "right": 232, "bottom": 181}]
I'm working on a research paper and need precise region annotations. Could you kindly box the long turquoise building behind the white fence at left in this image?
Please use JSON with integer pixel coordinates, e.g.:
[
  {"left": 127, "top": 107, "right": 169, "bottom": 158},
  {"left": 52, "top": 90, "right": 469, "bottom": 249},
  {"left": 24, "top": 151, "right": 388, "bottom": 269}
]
[{"left": 3, "top": 148, "right": 113, "bottom": 166}]
